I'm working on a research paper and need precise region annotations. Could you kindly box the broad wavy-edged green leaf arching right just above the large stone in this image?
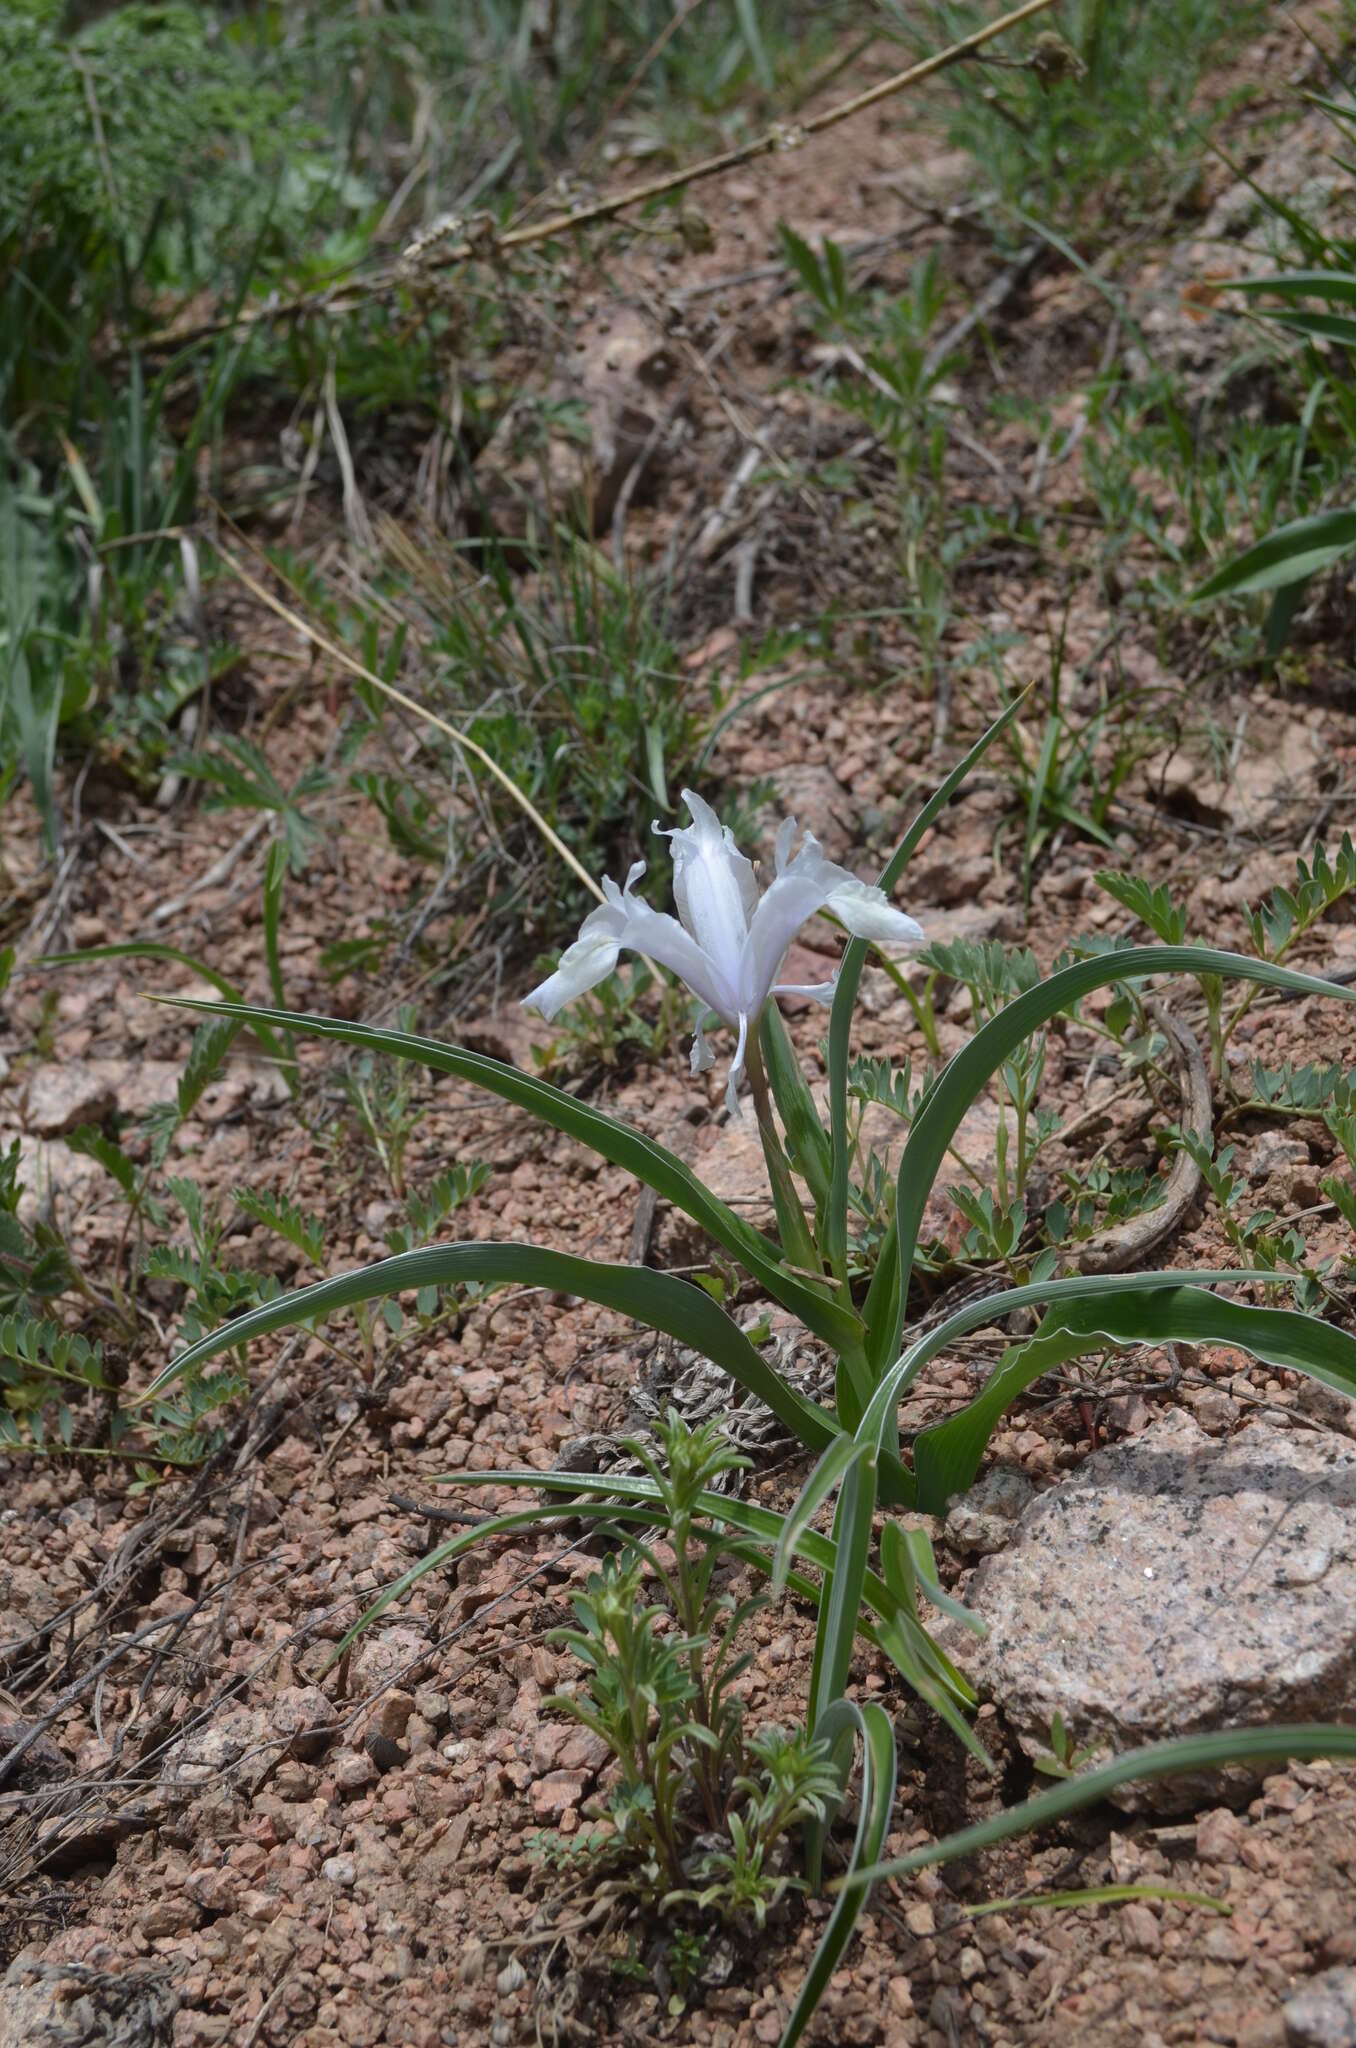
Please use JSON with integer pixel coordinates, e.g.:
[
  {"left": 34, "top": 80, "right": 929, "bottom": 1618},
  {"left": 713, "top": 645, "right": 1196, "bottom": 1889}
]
[{"left": 909, "top": 1286, "right": 1356, "bottom": 1516}]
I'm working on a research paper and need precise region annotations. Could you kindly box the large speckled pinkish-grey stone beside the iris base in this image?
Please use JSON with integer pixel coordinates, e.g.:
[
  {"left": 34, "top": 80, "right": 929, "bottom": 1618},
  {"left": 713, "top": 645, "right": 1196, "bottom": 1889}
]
[{"left": 965, "top": 1411, "right": 1356, "bottom": 1810}]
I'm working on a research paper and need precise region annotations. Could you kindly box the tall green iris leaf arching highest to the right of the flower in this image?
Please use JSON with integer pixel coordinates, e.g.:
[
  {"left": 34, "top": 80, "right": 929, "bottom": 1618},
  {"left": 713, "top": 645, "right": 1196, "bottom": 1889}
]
[{"left": 864, "top": 946, "right": 1356, "bottom": 1376}]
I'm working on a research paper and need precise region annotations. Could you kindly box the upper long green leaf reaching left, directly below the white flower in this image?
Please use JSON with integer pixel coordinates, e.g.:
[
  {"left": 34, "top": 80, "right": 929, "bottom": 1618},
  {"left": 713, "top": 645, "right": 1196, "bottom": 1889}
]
[{"left": 146, "top": 995, "right": 862, "bottom": 1350}]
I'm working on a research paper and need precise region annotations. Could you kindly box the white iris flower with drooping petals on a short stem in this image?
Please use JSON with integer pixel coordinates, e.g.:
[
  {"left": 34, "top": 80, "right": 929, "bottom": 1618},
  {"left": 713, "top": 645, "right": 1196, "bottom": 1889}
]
[{"left": 524, "top": 788, "right": 924, "bottom": 1114}]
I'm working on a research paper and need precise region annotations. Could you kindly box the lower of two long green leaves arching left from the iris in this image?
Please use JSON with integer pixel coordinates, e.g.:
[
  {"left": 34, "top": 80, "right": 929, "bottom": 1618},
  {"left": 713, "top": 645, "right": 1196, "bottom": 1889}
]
[{"left": 135, "top": 1243, "right": 838, "bottom": 1450}]
